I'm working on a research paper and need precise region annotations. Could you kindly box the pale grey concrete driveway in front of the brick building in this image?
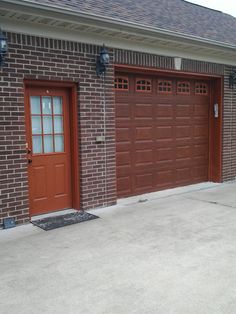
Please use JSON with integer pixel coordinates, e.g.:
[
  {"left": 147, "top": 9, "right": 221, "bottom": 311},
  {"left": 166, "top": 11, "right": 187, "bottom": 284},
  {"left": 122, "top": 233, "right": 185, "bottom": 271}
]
[{"left": 0, "top": 184, "right": 236, "bottom": 314}]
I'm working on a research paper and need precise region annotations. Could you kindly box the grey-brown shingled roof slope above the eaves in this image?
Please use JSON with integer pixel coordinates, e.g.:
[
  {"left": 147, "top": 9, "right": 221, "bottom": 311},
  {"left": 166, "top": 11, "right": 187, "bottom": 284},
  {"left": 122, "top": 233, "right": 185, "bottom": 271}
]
[{"left": 25, "top": 0, "right": 236, "bottom": 45}]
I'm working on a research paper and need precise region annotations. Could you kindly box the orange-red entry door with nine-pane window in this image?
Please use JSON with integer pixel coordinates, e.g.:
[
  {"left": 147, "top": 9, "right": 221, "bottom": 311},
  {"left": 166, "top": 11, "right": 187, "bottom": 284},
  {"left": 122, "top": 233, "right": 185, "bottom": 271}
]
[{"left": 26, "top": 87, "right": 72, "bottom": 215}]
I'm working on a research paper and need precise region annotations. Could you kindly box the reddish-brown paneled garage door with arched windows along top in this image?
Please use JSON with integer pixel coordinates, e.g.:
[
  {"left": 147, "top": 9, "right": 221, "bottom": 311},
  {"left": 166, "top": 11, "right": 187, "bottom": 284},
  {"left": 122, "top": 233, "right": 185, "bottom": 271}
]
[{"left": 115, "top": 74, "right": 210, "bottom": 197}]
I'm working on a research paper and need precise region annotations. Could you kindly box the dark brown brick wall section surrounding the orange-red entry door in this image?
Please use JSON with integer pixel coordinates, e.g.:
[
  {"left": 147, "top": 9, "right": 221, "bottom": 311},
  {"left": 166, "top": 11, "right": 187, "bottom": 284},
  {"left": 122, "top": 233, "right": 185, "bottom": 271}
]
[{"left": 0, "top": 33, "right": 116, "bottom": 225}]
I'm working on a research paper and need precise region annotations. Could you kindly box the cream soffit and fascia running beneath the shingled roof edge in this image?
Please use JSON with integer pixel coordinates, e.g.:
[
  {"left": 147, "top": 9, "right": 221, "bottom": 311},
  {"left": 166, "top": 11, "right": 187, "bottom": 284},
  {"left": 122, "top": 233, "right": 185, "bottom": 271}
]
[{"left": 0, "top": 0, "right": 236, "bottom": 66}]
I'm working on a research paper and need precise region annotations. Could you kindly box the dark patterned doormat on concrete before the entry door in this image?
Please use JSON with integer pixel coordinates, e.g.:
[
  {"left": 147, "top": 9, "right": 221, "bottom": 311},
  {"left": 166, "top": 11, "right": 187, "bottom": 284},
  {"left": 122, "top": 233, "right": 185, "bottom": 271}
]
[{"left": 31, "top": 210, "right": 99, "bottom": 231}]
